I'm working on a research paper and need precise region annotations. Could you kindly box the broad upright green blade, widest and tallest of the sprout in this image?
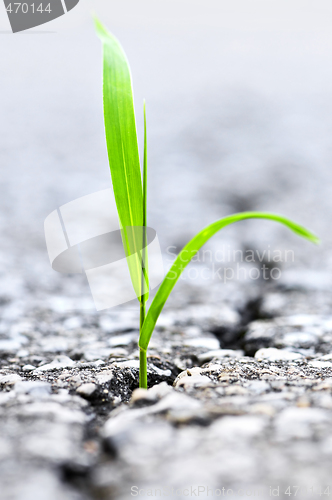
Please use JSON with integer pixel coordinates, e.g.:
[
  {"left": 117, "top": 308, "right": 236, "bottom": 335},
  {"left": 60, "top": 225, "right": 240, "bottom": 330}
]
[{"left": 95, "top": 19, "right": 143, "bottom": 300}]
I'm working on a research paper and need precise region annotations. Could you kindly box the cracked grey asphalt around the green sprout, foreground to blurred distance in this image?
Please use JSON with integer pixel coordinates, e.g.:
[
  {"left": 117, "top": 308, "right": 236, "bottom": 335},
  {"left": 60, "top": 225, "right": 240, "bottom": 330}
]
[{"left": 0, "top": 0, "right": 332, "bottom": 500}]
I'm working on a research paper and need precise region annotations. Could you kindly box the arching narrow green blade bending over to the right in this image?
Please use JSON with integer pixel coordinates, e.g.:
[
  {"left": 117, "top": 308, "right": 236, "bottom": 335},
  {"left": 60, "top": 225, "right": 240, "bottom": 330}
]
[{"left": 138, "top": 212, "right": 319, "bottom": 350}]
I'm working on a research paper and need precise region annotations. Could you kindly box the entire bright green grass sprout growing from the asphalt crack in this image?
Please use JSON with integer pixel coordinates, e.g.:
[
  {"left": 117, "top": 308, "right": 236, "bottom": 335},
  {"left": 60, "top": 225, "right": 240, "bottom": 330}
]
[{"left": 95, "top": 19, "right": 319, "bottom": 388}]
